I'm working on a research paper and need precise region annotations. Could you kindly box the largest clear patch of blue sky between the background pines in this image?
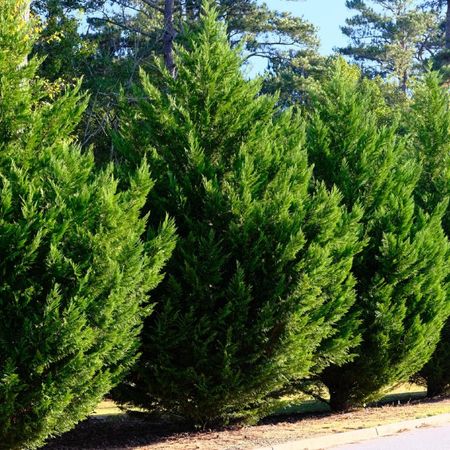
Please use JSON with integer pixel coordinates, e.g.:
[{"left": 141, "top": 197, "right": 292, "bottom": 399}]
[{"left": 265, "top": 0, "right": 349, "bottom": 54}]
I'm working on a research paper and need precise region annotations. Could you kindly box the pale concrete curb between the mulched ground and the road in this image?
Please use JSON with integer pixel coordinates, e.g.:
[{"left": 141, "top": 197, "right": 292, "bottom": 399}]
[{"left": 255, "top": 414, "right": 450, "bottom": 450}]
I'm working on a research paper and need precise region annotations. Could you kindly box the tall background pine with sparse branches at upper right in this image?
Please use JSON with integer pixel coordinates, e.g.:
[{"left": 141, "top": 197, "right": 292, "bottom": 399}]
[{"left": 340, "top": 0, "right": 443, "bottom": 91}]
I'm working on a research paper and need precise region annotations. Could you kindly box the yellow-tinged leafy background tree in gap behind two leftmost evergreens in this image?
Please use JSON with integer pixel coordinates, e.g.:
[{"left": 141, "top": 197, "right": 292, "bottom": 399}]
[{"left": 32, "top": 0, "right": 131, "bottom": 155}]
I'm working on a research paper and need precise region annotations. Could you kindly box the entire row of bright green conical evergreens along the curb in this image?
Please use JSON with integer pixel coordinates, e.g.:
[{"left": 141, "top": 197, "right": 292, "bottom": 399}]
[{"left": 0, "top": 0, "right": 450, "bottom": 449}]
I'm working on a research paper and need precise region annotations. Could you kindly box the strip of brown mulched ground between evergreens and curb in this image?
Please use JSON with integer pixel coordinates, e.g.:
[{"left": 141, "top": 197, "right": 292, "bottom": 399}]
[{"left": 45, "top": 392, "right": 450, "bottom": 450}]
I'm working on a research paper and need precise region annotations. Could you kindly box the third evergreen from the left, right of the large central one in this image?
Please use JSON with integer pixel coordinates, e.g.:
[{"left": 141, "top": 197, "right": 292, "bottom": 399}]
[{"left": 308, "top": 61, "right": 449, "bottom": 409}]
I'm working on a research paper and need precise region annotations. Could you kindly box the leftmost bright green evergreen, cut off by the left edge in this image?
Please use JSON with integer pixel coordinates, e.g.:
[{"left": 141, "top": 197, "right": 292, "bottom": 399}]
[{"left": 0, "top": 0, "right": 173, "bottom": 450}]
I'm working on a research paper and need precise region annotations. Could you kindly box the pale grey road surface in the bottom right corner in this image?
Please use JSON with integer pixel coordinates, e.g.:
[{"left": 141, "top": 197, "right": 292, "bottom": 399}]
[{"left": 333, "top": 425, "right": 450, "bottom": 450}]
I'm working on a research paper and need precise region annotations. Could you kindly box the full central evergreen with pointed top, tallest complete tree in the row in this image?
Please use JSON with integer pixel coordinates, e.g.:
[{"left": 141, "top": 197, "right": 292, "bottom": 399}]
[{"left": 118, "top": 2, "right": 359, "bottom": 425}]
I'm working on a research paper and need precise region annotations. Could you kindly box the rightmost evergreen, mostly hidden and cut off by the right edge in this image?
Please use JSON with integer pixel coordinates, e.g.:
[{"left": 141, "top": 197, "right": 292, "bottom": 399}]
[{"left": 404, "top": 72, "right": 450, "bottom": 396}]
